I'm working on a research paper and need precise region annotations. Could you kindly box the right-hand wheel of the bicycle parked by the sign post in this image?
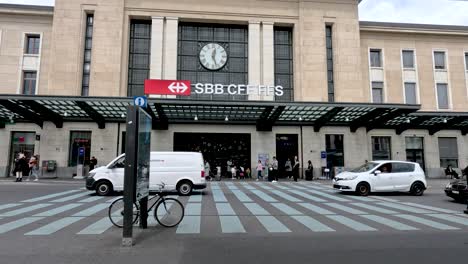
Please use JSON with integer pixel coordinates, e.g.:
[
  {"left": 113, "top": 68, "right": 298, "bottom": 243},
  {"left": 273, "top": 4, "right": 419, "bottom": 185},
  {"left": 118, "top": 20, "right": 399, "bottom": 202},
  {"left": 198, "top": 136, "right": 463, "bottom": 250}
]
[{"left": 154, "top": 198, "right": 184, "bottom": 227}]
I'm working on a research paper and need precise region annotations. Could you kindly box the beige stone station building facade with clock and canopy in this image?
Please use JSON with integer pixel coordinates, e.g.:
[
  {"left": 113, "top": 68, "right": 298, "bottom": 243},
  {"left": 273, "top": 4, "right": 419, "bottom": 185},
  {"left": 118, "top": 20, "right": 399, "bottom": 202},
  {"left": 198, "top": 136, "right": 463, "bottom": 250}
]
[{"left": 0, "top": 0, "right": 468, "bottom": 177}]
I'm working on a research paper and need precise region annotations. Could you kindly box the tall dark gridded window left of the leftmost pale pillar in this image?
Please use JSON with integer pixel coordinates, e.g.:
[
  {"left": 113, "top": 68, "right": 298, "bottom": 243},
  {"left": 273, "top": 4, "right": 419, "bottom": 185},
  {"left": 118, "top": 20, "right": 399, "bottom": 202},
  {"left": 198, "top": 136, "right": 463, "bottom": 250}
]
[{"left": 127, "top": 20, "right": 151, "bottom": 96}]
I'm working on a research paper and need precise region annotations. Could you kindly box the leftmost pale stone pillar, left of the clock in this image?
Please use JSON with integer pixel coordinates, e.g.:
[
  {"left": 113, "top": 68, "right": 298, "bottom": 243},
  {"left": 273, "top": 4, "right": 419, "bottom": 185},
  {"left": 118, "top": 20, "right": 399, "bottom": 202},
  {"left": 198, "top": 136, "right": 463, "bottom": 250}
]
[{"left": 150, "top": 17, "right": 164, "bottom": 79}]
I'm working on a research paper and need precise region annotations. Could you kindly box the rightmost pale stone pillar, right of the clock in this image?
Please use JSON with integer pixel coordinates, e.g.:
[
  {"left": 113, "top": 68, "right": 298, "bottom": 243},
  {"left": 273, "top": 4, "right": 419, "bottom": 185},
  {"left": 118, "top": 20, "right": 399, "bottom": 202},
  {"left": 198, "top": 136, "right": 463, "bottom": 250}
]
[{"left": 261, "top": 22, "right": 275, "bottom": 101}]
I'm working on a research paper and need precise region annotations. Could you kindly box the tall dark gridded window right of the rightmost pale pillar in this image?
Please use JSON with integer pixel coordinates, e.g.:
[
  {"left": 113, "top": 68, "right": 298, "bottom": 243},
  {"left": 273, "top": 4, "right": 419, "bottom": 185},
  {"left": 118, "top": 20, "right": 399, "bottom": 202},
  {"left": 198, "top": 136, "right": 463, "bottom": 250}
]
[{"left": 274, "top": 27, "right": 294, "bottom": 102}]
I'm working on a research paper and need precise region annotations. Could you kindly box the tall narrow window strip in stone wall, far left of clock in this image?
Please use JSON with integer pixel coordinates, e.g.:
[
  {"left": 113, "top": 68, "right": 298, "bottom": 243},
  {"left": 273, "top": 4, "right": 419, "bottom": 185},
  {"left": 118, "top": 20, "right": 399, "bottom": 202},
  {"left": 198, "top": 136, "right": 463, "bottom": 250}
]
[{"left": 81, "top": 14, "right": 94, "bottom": 96}]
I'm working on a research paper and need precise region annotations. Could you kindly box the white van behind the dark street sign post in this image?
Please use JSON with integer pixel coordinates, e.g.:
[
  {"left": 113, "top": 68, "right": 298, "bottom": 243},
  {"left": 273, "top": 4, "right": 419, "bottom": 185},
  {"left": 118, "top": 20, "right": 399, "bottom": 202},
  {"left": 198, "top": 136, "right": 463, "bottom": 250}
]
[{"left": 86, "top": 152, "right": 206, "bottom": 196}]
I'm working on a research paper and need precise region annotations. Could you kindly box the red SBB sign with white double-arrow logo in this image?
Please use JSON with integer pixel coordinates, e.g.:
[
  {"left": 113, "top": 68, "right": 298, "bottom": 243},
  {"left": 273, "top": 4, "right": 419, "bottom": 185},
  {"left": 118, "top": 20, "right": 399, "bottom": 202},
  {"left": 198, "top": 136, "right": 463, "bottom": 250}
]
[{"left": 145, "top": 80, "right": 191, "bottom": 96}]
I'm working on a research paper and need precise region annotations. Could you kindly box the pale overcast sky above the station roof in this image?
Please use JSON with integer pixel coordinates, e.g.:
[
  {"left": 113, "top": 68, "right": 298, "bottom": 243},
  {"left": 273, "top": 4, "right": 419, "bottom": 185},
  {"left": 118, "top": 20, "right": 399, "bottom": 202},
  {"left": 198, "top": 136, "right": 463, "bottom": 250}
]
[{"left": 0, "top": 0, "right": 468, "bottom": 26}]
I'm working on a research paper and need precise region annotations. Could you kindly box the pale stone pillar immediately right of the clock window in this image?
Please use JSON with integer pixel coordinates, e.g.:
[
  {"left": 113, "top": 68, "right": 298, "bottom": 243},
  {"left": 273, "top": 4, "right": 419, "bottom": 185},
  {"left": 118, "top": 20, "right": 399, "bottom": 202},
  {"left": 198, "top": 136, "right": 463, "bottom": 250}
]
[{"left": 248, "top": 21, "right": 261, "bottom": 100}]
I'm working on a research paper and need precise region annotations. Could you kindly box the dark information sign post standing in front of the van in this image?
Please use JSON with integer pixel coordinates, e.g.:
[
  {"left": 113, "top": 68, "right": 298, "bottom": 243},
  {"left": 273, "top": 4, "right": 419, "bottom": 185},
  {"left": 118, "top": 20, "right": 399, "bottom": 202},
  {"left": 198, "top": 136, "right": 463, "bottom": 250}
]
[{"left": 122, "top": 105, "right": 152, "bottom": 246}]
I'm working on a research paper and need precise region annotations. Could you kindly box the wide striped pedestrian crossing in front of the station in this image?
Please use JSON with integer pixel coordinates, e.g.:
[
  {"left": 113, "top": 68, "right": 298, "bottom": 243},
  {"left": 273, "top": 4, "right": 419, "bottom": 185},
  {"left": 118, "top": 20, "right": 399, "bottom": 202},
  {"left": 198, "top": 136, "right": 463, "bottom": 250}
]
[{"left": 0, "top": 182, "right": 468, "bottom": 236}]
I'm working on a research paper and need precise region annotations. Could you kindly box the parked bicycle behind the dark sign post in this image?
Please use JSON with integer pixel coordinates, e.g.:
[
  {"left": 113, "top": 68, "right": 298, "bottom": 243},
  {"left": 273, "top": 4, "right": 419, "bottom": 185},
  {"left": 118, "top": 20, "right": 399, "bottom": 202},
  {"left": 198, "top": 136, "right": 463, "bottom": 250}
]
[{"left": 108, "top": 184, "right": 185, "bottom": 228}]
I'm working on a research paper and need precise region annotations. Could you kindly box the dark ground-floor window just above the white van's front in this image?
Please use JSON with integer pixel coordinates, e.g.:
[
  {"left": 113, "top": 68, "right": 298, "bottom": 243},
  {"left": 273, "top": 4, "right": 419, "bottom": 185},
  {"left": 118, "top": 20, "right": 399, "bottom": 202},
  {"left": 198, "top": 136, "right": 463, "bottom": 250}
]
[{"left": 68, "top": 131, "right": 91, "bottom": 167}]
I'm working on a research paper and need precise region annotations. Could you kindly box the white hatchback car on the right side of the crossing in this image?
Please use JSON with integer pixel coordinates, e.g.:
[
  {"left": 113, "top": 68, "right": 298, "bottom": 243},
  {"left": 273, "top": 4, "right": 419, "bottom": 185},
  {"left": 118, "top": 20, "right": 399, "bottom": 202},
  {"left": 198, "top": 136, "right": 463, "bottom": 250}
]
[{"left": 333, "top": 160, "right": 427, "bottom": 196}]
